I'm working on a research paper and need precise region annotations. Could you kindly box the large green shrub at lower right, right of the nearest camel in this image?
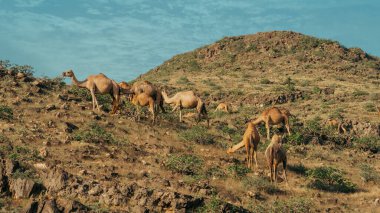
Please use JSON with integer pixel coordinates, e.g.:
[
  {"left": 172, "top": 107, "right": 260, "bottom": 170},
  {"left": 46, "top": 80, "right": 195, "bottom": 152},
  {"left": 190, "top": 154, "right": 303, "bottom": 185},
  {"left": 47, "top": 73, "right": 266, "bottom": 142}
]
[{"left": 306, "top": 166, "right": 357, "bottom": 193}]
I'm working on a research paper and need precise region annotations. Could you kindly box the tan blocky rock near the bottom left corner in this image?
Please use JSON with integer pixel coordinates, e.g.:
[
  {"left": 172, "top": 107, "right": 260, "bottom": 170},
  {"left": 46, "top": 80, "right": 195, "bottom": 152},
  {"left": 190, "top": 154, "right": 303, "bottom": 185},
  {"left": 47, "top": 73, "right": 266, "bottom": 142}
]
[{"left": 10, "top": 178, "right": 37, "bottom": 199}]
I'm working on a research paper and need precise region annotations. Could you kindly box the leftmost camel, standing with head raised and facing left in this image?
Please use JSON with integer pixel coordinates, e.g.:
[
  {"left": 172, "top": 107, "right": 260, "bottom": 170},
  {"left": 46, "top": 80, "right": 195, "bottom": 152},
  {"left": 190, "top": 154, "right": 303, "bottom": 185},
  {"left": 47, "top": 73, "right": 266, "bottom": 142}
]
[{"left": 62, "top": 70, "right": 120, "bottom": 114}]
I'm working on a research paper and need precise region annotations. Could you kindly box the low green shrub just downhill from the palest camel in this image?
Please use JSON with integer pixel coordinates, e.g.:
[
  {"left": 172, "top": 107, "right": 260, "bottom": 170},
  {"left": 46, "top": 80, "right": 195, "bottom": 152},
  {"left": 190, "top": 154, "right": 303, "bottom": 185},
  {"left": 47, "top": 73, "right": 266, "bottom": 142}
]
[{"left": 179, "top": 126, "right": 214, "bottom": 145}]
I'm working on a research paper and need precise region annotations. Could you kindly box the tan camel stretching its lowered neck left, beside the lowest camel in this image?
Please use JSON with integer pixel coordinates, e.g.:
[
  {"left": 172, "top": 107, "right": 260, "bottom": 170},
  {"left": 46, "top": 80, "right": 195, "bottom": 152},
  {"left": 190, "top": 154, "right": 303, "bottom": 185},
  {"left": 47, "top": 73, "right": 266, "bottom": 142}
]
[{"left": 227, "top": 122, "right": 260, "bottom": 169}]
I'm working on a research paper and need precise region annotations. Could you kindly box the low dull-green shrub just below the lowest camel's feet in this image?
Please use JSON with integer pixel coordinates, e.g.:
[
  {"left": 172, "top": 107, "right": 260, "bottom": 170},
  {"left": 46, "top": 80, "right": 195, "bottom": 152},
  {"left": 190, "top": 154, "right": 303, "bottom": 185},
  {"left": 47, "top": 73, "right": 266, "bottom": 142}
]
[{"left": 243, "top": 177, "right": 282, "bottom": 194}]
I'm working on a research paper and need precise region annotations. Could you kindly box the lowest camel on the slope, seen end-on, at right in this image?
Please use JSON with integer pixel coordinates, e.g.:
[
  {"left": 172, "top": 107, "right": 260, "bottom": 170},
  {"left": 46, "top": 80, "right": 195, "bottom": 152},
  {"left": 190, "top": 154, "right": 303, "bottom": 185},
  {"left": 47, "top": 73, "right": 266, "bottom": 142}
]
[{"left": 265, "top": 134, "right": 288, "bottom": 184}]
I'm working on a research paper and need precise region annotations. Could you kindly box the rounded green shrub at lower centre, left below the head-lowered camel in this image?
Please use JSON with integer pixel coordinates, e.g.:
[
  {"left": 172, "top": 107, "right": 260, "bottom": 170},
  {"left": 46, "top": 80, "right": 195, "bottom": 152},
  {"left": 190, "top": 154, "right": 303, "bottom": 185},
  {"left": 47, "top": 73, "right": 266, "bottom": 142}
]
[{"left": 165, "top": 154, "right": 203, "bottom": 175}]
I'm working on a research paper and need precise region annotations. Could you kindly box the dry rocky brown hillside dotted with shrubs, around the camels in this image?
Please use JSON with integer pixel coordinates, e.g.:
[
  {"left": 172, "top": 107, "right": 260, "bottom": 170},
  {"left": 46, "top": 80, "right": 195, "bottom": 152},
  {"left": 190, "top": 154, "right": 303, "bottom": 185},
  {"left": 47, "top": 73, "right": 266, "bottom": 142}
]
[{"left": 0, "top": 31, "right": 380, "bottom": 212}]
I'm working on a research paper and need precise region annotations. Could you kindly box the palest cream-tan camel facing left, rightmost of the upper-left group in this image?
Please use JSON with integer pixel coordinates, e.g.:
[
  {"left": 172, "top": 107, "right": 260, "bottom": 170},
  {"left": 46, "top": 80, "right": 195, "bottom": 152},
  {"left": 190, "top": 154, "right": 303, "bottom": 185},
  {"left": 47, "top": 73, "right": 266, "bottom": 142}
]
[{"left": 162, "top": 91, "right": 210, "bottom": 126}]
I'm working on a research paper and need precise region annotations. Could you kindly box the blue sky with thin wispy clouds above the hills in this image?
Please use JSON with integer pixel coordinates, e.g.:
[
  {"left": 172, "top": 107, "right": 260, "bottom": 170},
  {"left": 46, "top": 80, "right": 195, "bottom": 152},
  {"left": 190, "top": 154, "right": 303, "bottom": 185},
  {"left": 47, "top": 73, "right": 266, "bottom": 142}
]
[{"left": 0, "top": 0, "right": 380, "bottom": 81}]
